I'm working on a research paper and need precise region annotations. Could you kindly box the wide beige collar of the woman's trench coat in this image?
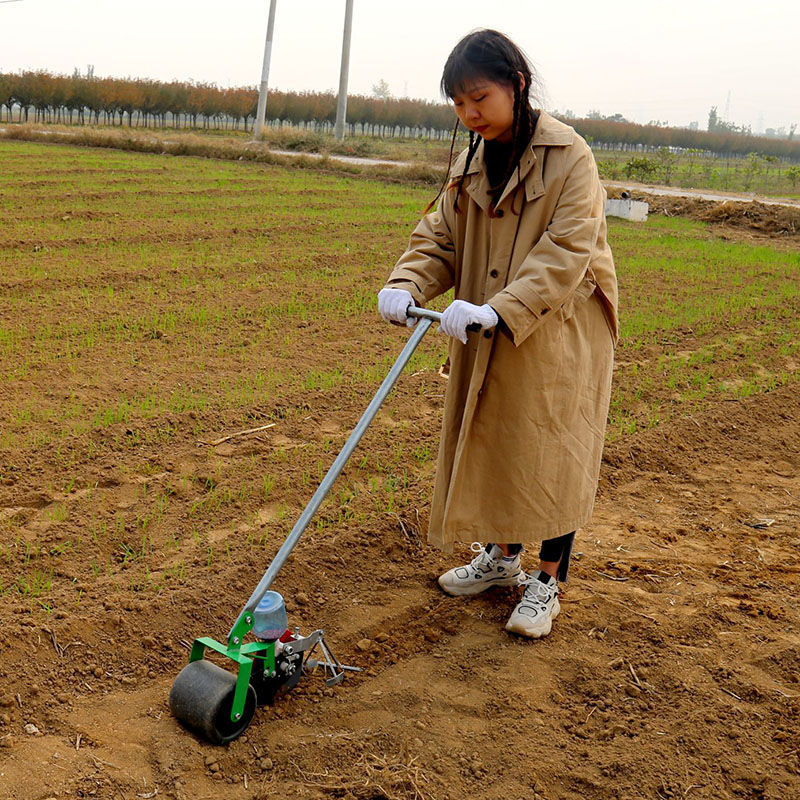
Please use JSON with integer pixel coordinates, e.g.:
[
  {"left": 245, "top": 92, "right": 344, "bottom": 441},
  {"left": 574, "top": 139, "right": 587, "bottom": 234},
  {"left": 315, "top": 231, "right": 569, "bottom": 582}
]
[{"left": 453, "top": 111, "right": 576, "bottom": 211}]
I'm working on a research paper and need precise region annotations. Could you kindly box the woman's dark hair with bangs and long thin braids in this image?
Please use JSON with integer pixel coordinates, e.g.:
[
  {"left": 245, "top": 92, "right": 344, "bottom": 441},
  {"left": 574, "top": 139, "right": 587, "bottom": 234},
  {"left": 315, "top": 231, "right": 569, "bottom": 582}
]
[{"left": 428, "top": 29, "right": 538, "bottom": 214}]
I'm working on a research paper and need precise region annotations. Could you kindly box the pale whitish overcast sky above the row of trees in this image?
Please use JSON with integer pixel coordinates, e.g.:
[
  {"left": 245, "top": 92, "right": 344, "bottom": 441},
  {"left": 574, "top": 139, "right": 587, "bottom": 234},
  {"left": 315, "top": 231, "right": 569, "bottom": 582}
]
[{"left": 0, "top": 0, "right": 800, "bottom": 132}]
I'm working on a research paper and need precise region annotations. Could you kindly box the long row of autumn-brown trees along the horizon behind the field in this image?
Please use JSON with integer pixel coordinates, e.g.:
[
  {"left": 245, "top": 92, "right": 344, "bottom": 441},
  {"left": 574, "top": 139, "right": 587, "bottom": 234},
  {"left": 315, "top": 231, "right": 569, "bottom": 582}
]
[{"left": 0, "top": 72, "right": 800, "bottom": 161}]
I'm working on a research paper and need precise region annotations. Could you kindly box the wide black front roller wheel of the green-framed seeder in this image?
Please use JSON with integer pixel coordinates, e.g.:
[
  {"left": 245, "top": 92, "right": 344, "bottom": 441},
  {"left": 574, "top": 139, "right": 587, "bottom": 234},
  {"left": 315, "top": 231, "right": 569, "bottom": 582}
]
[{"left": 169, "top": 659, "right": 256, "bottom": 744}]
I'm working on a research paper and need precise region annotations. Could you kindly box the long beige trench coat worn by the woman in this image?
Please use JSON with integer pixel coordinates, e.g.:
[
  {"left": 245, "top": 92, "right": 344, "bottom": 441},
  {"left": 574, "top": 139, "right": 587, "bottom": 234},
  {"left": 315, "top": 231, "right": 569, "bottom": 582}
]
[{"left": 386, "top": 113, "right": 618, "bottom": 551}]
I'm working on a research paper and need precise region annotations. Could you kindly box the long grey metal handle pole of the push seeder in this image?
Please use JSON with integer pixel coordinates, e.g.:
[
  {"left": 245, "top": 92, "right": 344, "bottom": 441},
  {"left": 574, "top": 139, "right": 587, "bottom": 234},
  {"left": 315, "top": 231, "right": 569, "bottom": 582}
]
[{"left": 228, "top": 316, "right": 434, "bottom": 638}]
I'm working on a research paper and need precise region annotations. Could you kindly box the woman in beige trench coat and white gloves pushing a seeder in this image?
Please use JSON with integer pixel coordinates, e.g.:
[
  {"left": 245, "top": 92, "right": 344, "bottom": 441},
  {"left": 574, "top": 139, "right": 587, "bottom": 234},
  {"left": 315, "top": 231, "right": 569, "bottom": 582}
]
[{"left": 378, "top": 30, "right": 618, "bottom": 638}]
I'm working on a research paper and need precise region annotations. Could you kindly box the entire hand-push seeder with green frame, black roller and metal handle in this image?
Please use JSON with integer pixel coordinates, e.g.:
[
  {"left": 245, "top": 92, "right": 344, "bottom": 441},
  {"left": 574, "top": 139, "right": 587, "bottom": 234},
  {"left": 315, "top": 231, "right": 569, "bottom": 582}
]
[{"left": 169, "top": 307, "right": 480, "bottom": 744}]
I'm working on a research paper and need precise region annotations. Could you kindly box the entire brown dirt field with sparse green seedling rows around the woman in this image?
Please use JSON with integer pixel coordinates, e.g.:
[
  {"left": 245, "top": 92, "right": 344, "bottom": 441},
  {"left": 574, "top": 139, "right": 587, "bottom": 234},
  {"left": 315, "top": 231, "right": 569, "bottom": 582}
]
[{"left": 0, "top": 144, "right": 800, "bottom": 800}]
